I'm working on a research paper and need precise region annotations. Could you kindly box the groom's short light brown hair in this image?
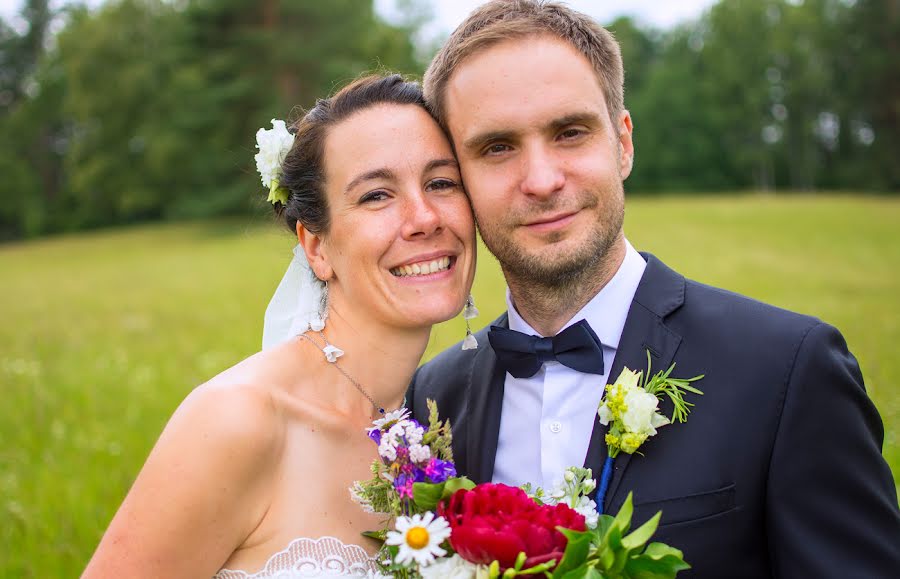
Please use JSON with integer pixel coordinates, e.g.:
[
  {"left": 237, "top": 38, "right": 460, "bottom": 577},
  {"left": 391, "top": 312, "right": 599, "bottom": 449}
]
[{"left": 424, "top": 0, "right": 625, "bottom": 128}]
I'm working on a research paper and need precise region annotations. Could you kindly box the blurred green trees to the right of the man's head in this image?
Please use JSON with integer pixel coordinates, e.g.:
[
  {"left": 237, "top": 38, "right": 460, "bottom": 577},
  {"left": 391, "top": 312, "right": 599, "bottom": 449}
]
[{"left": 612, "top": 0, "right": 900, "bottom": 192}]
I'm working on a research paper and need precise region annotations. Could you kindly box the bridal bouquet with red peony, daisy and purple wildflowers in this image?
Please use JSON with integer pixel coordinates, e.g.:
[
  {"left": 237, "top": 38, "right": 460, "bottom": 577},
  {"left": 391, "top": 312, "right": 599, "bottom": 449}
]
[{"left": 350, "top": 400, "right": 690, "bottom": 579}]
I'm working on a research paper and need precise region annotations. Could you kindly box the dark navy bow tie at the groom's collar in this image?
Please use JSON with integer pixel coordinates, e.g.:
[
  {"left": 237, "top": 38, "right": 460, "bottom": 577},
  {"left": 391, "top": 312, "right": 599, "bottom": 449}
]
[{"left": 488, "top": 320, "right": 603, "bottom": 378}]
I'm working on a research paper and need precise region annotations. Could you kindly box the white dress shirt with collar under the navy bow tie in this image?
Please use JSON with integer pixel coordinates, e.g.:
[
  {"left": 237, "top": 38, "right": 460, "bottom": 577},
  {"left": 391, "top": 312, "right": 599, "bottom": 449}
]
[{"left": 493, "top": 240, "right": 647, "bottom": 489}]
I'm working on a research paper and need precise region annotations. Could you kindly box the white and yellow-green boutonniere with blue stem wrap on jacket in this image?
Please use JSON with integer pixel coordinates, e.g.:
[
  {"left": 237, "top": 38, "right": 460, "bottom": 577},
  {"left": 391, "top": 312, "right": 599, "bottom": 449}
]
[{"left": 597, "top": 352, "right": 704, "bottom": 512}]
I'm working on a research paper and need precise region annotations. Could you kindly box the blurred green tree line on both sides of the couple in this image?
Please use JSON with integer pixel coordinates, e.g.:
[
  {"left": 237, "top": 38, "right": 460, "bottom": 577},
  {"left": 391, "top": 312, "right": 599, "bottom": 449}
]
[{"left": 0, "top": 0, "right": 900, "bottom": 239}]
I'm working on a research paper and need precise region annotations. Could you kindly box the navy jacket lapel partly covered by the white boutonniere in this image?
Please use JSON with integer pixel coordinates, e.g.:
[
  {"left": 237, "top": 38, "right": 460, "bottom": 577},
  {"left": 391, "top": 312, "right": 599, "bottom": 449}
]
[{"left": 585, "top": 253, "right": 685, "bottom": 512}]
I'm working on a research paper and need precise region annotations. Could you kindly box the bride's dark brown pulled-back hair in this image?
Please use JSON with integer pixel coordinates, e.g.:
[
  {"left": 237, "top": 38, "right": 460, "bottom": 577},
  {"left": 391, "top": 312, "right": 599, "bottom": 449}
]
[{"left": 275, "top": 74, "right": 428, "bottom": 233}]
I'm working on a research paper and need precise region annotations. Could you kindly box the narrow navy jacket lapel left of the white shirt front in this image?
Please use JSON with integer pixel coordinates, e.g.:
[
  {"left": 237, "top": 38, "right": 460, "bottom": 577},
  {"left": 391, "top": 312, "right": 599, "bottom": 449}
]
[{"left": 466, "top": 314, "right": 509, "bottom": 483}]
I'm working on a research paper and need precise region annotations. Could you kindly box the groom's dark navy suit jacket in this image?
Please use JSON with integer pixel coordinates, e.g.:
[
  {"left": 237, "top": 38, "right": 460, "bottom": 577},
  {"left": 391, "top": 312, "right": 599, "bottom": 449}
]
[{"left": 407, "top": 254, "right": 900, "bottom": 578}]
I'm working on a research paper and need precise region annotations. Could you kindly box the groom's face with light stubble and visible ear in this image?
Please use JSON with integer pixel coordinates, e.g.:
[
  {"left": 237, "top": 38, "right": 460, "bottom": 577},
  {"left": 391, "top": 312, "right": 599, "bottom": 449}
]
[{"left": 445, "top": 36, "right": 633, "bottom": 286}]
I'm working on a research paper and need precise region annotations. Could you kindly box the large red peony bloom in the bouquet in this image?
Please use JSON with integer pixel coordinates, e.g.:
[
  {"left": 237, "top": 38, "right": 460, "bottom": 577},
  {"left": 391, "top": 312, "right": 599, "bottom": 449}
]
[{"left": 438, "top": 484, "right": 585, "bottom": 569}]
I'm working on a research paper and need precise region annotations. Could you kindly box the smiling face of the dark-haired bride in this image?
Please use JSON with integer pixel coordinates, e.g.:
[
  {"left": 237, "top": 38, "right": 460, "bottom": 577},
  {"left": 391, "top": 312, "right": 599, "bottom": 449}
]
[{"left": 314, "top": 104, "right": 475, "bottom": 327}]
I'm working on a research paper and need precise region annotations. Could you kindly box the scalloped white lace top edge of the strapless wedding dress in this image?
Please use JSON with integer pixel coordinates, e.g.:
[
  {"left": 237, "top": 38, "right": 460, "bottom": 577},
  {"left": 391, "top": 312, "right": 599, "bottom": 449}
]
[{"left": 213, "top": 537, "right": 384, "bottom": 579}]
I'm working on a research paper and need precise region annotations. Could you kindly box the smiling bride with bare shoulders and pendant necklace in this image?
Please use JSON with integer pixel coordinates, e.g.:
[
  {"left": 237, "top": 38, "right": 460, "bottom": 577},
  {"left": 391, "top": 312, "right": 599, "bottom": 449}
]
[{"left": 83, "top": 75, "right": 475, "bottom": 579}]
